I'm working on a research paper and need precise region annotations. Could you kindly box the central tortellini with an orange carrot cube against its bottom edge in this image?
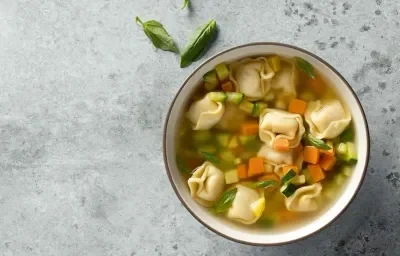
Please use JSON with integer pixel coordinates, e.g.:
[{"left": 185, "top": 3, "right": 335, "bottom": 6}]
[{"left": 259, "top": 108, "right": 305, "bottom": 148}]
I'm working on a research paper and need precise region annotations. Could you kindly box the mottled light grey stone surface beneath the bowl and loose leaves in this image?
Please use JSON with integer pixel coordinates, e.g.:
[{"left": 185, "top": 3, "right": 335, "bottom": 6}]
[{"left": 0, "top": 0, "right": 400, "bottom": 256}]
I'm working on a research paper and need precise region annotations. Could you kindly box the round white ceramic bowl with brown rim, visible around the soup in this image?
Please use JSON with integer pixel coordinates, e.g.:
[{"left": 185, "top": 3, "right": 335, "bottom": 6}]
[{"left": 163, "top": 42, "right": 370, "bottom": 245}]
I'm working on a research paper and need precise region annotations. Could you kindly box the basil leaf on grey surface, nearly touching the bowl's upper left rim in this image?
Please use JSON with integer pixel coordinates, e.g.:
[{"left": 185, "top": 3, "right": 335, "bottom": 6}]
[{"left": 181, "top": 19, "right": 217, "bottom": 68}]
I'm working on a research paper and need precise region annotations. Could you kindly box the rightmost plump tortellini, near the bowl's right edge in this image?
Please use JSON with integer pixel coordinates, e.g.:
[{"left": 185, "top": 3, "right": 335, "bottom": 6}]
[{"left": 304, "top": 99, "right": 351, "bottom": 139}]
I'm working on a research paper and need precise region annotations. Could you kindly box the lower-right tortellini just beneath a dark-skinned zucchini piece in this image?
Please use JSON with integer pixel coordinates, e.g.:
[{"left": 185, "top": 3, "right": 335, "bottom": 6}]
[{"left": 285, "top": 183, "right": 322, "bottom": 212}]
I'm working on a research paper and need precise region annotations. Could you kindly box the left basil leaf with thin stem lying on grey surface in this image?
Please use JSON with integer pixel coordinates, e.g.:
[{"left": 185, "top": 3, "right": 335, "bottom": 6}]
[{"left": 136, "top": 16, "right": 179, "bottom": 52}]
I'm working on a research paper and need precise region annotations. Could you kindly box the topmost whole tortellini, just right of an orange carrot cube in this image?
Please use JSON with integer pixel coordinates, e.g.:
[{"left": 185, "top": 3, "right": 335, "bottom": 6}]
[{"left": 229, "top": 57, "right": 275, "bottom": 101}]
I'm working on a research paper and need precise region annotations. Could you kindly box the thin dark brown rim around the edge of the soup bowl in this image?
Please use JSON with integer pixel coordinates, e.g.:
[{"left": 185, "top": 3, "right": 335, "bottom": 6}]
[{"left": 162, "top": 42, "right": 370, "bottom": 246}]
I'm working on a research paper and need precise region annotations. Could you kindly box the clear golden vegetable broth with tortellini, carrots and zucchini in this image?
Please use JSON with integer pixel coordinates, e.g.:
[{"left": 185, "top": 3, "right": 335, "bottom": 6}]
[{"left": 176, "top": 55, "right": 357, "bottom": 228}]
